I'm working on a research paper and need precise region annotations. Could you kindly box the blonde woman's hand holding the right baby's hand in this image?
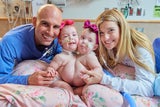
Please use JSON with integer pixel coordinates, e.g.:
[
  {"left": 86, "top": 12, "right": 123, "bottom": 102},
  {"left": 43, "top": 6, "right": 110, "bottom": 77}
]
[{"left": 81, "top": 70, "right": 103, "bottom": 85}]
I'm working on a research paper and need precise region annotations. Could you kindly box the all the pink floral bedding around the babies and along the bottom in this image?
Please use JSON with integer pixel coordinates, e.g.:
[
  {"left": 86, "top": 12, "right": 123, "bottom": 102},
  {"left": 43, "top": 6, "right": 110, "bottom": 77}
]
[{"left": 0, "top": 60, "right": 160, "bottom": 107}]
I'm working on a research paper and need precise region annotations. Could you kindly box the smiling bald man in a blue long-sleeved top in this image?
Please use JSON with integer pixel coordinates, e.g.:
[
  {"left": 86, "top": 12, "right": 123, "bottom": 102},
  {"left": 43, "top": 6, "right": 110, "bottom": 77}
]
[{"left": 0, "top": 4, "right": 62, "bottom": 86}]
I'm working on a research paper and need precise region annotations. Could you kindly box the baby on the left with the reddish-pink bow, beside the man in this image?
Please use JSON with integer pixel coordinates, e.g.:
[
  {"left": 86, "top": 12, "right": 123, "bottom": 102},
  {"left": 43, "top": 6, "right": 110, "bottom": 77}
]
[{"left": 47, "top": 20, "right": 79, "bottom": 92}]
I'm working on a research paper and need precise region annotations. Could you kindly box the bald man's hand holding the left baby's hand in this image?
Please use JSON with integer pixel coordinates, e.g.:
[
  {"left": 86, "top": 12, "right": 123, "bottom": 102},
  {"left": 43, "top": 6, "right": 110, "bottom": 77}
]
[{"left": 28, "top": 70, "right": 54, "bottom": 86}]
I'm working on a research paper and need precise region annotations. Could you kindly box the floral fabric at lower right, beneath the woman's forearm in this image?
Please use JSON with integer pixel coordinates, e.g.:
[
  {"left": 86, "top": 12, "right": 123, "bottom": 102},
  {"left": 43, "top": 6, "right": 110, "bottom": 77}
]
[{"left": 83, "top": 84, "right": 160, "bottom": 107}]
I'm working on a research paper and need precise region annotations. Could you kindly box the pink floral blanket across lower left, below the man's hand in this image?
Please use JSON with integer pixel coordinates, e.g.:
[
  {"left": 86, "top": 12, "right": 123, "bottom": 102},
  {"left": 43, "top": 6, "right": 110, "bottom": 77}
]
[{"left": 0, "top": 84, "right": 86, "bottom": 107}]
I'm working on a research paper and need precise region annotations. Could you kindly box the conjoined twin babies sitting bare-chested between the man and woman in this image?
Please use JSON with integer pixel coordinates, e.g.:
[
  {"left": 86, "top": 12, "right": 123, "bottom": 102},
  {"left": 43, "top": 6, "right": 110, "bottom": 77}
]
[{"left": 47, "top": 20, "right": 102, "bottom": 95}]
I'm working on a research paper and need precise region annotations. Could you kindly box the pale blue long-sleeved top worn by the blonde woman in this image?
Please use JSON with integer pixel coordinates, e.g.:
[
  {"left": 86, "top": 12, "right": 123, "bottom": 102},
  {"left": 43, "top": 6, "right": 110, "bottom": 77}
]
[{"left": 101, "top": 48, "right": 155, "bottom": 96}]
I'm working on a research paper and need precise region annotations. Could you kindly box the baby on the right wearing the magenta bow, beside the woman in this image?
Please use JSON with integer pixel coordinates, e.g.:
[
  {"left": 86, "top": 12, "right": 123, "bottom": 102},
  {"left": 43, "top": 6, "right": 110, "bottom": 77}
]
[{"left": 74, "top": 20, "right": 102, "bottom": 95}]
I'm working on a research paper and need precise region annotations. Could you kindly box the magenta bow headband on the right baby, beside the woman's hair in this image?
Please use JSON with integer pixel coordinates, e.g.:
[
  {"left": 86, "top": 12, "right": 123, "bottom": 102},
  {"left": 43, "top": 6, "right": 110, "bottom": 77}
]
[{"left": 83, "top": 20, "right": 98, "bottom": 44}]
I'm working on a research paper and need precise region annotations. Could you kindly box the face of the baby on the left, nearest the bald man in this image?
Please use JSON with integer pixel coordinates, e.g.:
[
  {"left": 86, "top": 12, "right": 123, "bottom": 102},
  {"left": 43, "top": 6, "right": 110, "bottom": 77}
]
[{"left": 60, "top": 25, "right": 79, "bottom": 52}]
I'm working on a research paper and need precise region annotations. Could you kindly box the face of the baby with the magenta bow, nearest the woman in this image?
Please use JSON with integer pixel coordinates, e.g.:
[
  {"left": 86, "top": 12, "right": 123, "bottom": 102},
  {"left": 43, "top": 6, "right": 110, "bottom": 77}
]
[{"left": 78, "top": 29, "right": 96, "bottom": 54}]
